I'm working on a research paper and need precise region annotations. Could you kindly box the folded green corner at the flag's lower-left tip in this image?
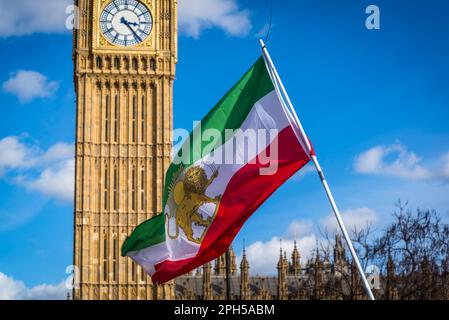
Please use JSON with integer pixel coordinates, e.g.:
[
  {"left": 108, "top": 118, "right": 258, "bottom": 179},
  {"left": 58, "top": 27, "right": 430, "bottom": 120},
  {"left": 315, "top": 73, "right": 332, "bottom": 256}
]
[{"left": 122, "top": 214, "right": 165, "bottom": 256}]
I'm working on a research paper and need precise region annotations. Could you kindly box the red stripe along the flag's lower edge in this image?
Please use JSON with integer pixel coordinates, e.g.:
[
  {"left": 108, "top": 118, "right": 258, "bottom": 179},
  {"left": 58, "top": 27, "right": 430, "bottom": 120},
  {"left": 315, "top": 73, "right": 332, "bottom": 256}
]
[{"left": 152, "top": 127, "right": 310, "bottom": 284}]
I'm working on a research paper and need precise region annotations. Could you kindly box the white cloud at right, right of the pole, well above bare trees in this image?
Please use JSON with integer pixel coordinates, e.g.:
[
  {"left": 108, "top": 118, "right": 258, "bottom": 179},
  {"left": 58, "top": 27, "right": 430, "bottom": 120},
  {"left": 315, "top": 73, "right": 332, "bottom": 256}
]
[{"left": 354, "top": 143, "right": 435, "bottom": 180}]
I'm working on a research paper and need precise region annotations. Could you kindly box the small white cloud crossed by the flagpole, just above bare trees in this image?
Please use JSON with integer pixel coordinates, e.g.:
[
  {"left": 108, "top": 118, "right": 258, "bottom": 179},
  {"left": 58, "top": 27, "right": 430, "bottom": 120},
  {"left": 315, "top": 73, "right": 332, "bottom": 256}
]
[{"left": 320, "top": 207, "right": 378, "bottom": 233}]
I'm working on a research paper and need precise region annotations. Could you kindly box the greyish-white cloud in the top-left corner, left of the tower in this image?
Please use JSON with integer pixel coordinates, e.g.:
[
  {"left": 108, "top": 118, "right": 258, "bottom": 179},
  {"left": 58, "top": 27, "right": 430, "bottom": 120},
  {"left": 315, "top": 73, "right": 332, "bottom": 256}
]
[{"left": 0, "top": 0, "right": 73, "bottom": 38}]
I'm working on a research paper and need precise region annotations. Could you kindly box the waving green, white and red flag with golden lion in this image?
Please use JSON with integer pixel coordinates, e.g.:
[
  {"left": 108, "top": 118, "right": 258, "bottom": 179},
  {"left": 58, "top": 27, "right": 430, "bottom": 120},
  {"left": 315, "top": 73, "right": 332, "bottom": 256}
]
[{"left": 122, "top": 57, "right": 313, "bottom": 284}]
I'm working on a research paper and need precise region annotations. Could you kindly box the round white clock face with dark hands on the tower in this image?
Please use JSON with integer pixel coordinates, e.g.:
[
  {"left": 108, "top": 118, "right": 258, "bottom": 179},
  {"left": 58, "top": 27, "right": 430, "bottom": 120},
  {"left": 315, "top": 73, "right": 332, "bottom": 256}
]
[{"left": 100, "top": 0, "right": 153, "bottom": 47}]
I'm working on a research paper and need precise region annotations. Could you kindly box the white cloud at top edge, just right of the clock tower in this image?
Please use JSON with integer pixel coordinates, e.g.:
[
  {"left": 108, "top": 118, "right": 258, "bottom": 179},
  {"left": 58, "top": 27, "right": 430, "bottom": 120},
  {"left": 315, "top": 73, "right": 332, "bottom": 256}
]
[{"left": 178, "top": 0, "right": 251, "bottom": 39}]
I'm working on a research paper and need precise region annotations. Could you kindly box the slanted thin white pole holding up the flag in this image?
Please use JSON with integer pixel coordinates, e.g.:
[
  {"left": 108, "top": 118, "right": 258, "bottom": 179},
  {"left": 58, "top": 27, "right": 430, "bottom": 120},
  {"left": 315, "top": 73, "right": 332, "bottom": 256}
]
[{"left": 259, "top": 39, "right": 375, "bottom": 300}]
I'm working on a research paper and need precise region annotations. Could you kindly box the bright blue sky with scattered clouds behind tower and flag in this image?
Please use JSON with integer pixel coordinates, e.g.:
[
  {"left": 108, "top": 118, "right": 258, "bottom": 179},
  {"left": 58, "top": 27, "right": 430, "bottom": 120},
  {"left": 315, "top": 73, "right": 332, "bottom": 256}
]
[{"left": 0, "top": 0, "right": 449, "bottom": 298}]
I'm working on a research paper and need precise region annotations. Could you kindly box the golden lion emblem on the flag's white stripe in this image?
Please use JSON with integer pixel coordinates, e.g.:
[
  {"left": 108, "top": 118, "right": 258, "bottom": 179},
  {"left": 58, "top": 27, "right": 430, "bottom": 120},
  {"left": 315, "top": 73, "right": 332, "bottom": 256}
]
[{"left": 166, "top": 167, "right": 221, "bottom": 244}]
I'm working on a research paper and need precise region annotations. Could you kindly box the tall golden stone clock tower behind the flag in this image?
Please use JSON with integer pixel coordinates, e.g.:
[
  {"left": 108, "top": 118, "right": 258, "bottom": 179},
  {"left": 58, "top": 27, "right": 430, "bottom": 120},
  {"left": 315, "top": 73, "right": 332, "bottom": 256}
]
[{"left": 73, "top": 0, "right": 177, "bottom": 299}]
